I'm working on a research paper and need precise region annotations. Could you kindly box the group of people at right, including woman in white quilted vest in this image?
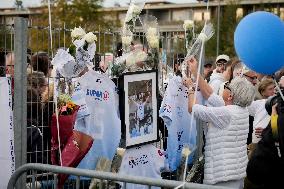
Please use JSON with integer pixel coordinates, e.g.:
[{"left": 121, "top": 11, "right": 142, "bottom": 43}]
[{"left": 181, "top": 55, "right": 284, "bottom": 188}]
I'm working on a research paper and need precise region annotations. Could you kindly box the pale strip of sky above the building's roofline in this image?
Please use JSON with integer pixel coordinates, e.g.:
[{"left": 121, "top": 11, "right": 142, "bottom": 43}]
[{"left": 0, "top": 0, "right": 196, "bottom": 8}]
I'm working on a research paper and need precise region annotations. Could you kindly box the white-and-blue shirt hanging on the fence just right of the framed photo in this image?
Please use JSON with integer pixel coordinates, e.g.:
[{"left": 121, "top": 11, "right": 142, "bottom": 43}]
[{"left": 160, "top": 76, "right": 197, "bottom": 171}]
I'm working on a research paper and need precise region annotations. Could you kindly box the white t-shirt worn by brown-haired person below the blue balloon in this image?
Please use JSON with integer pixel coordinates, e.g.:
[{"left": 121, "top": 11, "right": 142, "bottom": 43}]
[{"left": 248, "top": 99, "right": 270, "bottom": 143}]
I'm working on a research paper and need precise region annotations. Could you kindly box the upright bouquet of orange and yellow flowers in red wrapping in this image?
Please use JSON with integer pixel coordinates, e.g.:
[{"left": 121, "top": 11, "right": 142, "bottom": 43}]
[{"left": 50, "top": 94, "right": 79, "bottom": 165}]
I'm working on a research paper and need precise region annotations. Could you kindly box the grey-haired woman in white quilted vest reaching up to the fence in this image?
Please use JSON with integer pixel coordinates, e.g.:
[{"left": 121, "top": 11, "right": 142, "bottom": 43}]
[{"left": 185, "top": 59, "right": 255, "bottom": 188}]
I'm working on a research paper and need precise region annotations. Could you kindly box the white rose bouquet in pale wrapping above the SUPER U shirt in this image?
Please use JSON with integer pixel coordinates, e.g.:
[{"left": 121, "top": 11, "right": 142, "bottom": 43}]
[{"left": 51, "top": 27, "right": 97, "bottom": 78}]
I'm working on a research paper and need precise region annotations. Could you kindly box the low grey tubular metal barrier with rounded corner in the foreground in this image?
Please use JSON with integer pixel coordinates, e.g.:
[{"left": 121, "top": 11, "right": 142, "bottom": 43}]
[{"left": 7, "top": 163, "right": 231, "bottom": 189}]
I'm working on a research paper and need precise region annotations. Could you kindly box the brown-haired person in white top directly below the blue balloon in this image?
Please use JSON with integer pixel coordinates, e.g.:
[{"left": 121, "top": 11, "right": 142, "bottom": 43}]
[{"left": 248, "top": 79, "right": 275, "bottom": 157}]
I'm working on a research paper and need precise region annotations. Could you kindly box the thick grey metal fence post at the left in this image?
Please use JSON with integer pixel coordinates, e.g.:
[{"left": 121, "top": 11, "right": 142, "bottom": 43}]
[{"left": 14, "top": 17, "right": 28, "bottom": 188}]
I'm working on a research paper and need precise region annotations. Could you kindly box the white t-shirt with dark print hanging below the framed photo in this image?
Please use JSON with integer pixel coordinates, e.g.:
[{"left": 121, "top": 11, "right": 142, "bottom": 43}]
[{"left": 119, "top": 144, "right": 167, "bottom": 189}]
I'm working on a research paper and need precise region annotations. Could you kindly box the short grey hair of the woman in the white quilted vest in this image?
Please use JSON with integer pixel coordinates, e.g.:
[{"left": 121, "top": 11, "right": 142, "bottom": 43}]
[{"left": 229, "top": 77, "right": 256, "bottom": 107}]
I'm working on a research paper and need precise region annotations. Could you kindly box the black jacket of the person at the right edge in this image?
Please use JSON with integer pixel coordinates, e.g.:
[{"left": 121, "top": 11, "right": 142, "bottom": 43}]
[{"left": 247, "top": 114, "right": 284, "bottom": 189}]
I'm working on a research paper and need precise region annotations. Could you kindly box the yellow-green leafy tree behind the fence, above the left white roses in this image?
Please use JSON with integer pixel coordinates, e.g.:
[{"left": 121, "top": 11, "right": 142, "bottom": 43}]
[{"left": 30, "top": 0, "right": 119, "bottom": 51}]
